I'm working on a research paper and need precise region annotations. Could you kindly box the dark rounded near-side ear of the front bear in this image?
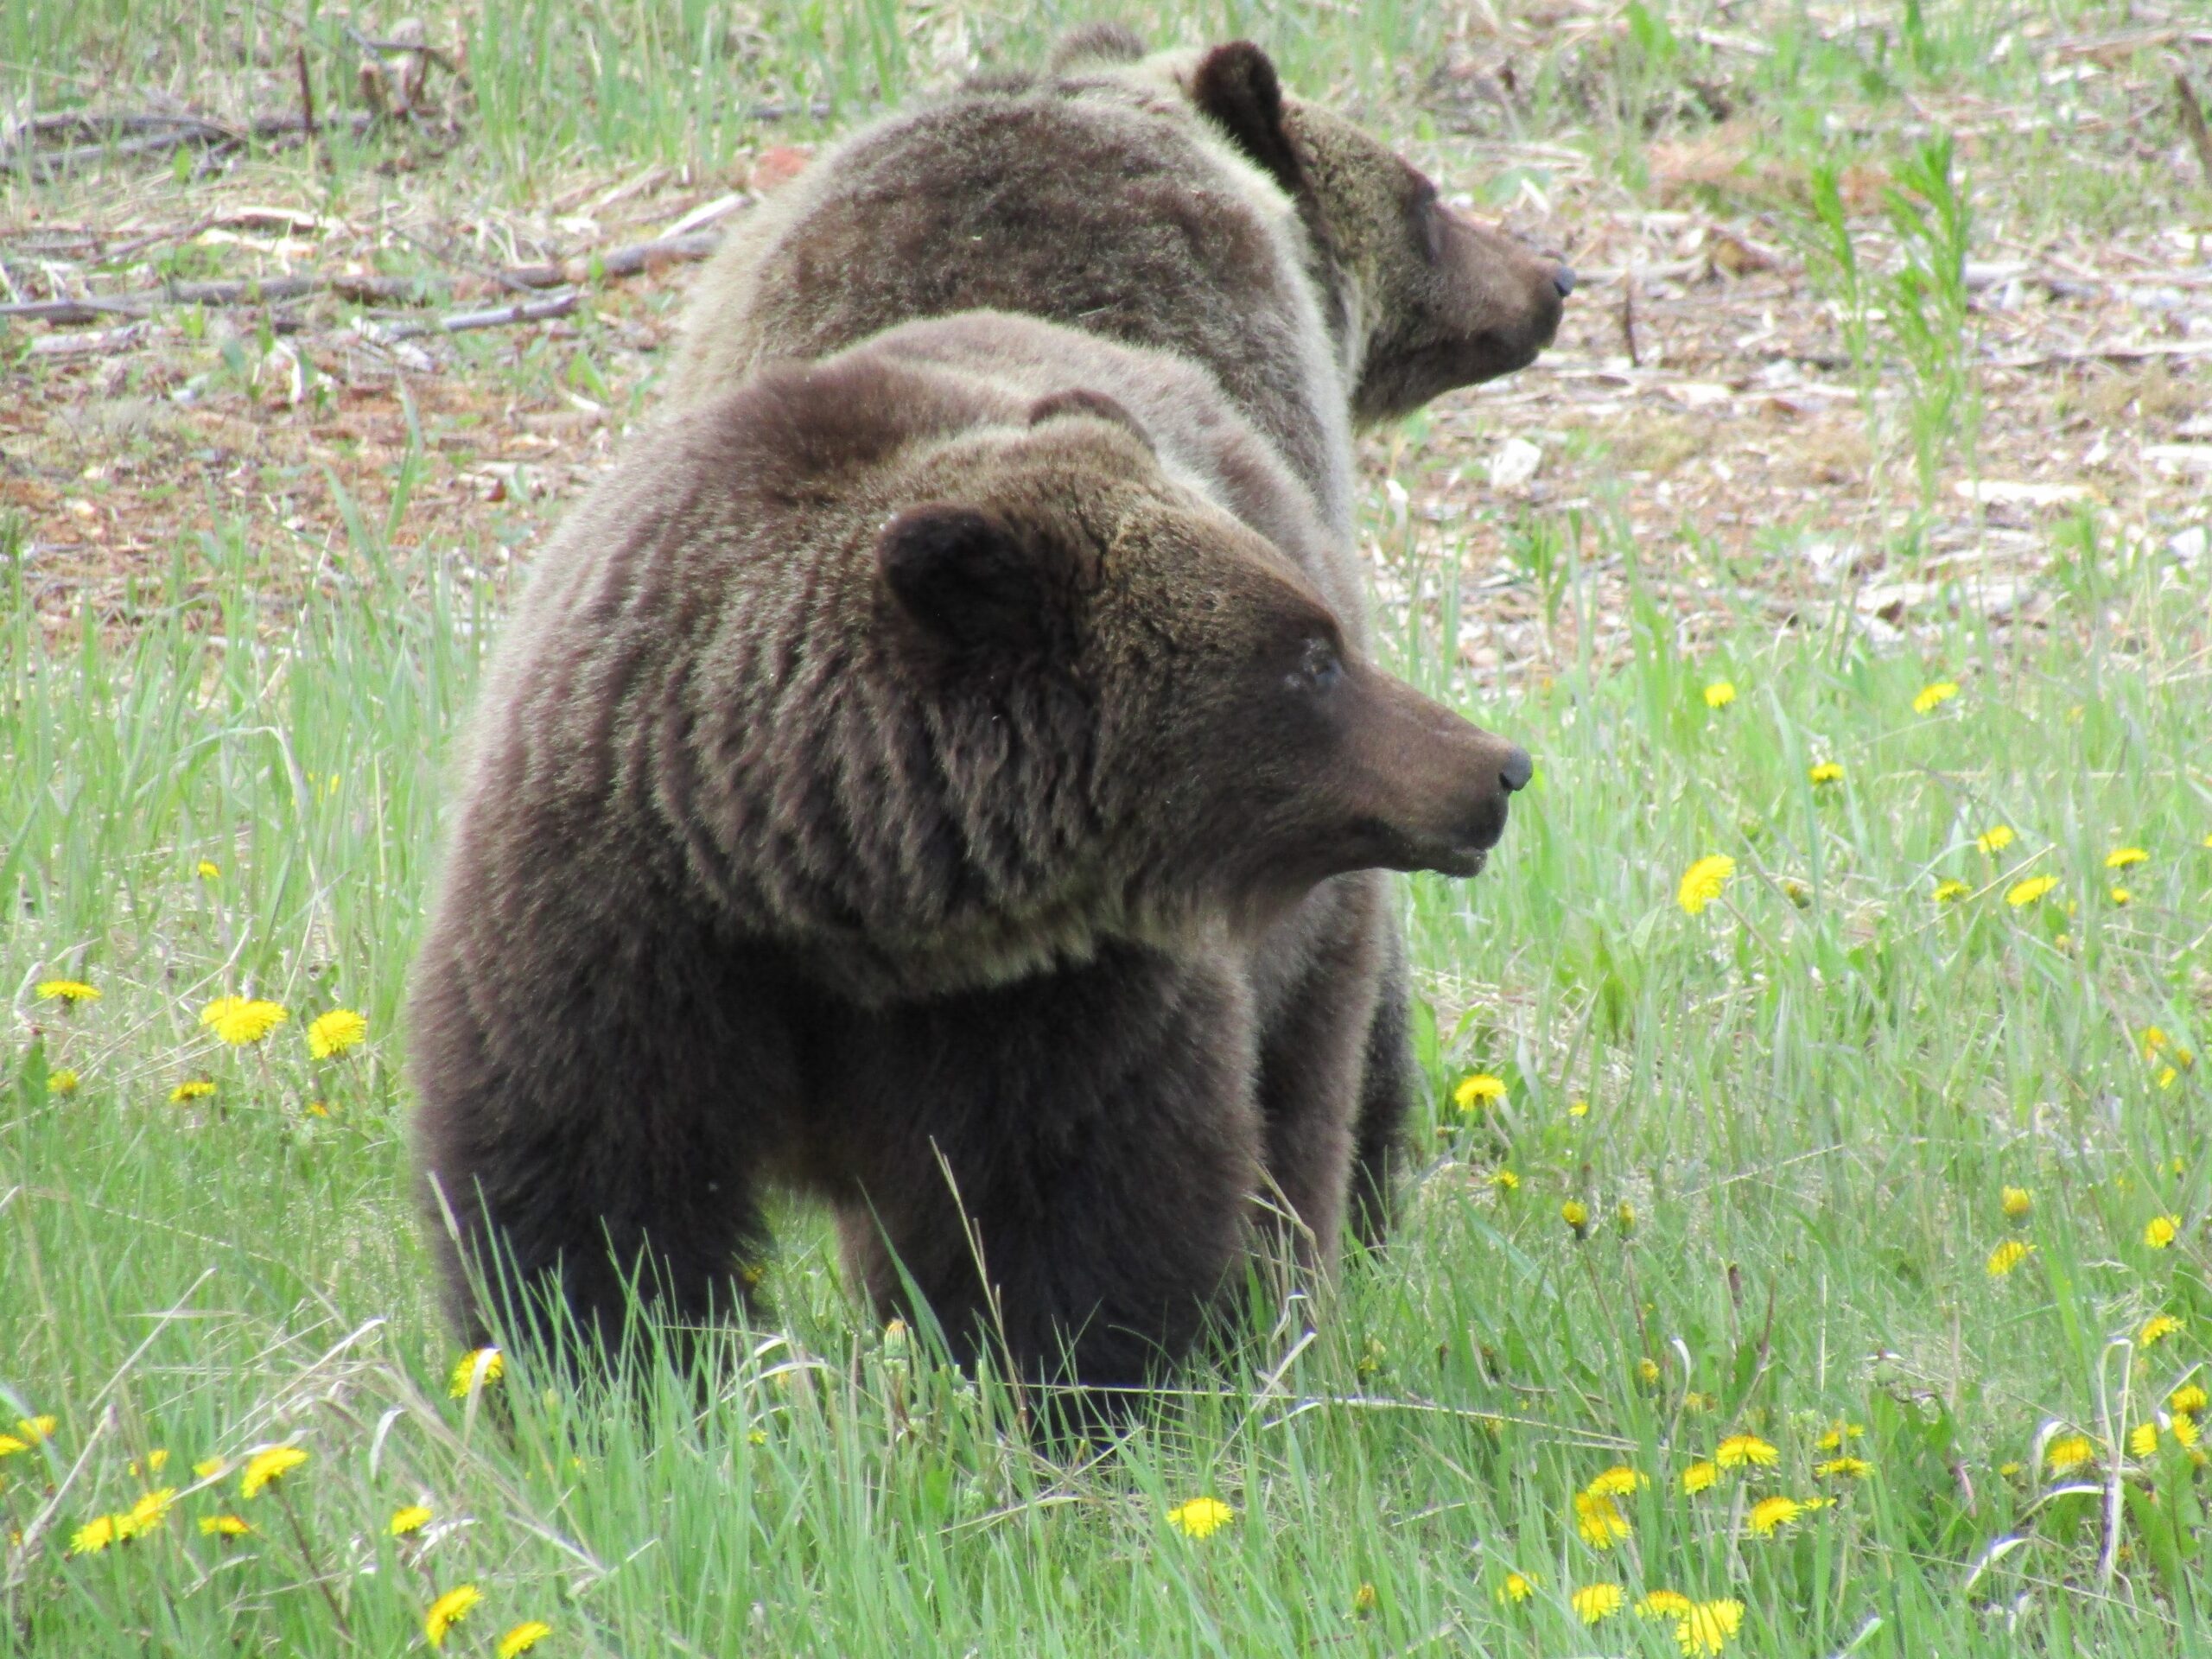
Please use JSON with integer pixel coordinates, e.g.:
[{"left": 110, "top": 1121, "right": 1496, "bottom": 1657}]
[{"left": 876, "top": 502, "right": 1058, "bottom": 655}]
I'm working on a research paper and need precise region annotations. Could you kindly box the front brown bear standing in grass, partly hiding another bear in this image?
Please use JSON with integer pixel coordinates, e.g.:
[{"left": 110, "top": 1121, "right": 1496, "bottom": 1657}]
[{"left": 411, "top": 316, "right": 1529, "bottom": 1385}]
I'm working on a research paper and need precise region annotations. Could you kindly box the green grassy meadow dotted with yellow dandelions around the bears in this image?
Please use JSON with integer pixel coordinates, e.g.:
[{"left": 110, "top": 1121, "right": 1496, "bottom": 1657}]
[{"left": 0, "top": 0, "right": 2212, "bottom": 1659}]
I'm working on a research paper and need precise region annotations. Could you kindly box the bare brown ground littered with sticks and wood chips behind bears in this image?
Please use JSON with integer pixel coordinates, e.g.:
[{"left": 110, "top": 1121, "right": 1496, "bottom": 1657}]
[{"left": 0, "top": 24, "right": 2212, "bottom": 672}]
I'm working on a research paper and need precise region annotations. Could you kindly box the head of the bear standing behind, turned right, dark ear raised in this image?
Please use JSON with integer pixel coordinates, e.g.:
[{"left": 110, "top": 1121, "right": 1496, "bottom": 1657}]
[{"left": 1177, "top": 40, "right": 1575, "bottom": 425}]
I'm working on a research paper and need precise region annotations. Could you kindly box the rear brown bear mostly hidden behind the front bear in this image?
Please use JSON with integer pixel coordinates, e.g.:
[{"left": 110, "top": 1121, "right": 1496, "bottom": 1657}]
[{"left": 671, "top": 27, "right": 1573, "bottom": 1263}]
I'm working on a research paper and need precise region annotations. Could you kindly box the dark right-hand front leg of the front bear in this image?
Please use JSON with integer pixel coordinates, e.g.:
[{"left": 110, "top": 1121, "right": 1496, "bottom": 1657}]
[{"left": 832, "top": 944, "right": 1261, "bottom": 1407}]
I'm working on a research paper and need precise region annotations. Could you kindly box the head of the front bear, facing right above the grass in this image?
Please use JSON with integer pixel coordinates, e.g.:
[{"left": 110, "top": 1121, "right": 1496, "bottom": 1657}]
[{"left": 874, "top": 394, "right": 1529, "bottom": 925}]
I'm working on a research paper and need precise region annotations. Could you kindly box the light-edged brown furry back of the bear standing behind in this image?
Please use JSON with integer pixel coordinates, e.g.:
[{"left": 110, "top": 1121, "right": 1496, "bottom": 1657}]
[{"left": 672, "top": 78, "right": 1350, "bottom": 531}]
